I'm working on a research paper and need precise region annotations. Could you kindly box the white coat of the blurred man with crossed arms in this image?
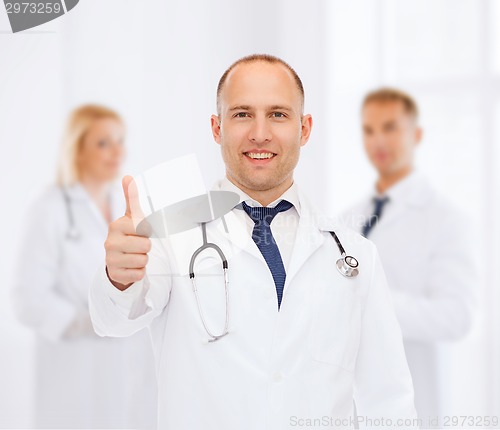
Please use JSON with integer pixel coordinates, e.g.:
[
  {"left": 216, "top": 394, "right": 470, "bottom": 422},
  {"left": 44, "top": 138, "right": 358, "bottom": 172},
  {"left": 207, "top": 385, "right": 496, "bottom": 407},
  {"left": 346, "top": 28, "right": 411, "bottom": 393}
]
[{"left": 340, "top": 172, "right": 478, "bottom": 423}]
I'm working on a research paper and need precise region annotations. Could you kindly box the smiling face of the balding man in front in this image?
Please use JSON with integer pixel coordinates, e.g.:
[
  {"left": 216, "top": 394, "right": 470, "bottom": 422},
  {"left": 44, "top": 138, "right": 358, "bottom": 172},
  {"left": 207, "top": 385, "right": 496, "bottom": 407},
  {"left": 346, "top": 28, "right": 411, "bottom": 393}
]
[{"left": 211, "top": 61, "right": 312, "bottom": 205}]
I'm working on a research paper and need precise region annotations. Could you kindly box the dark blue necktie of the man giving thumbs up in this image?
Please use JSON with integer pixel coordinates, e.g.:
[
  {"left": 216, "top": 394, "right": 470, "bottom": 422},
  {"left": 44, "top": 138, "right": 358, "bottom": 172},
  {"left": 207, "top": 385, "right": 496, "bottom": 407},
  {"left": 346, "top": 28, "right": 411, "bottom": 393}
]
[{"left": 242, "top": 200, "right": 293, "bottom": 310}]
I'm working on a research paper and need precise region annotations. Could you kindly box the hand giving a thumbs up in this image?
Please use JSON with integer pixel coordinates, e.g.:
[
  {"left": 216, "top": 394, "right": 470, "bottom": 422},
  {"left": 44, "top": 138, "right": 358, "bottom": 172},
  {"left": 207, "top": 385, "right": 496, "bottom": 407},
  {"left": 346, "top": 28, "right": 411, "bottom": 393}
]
[{"left": 104, "top": 176, "right": 151, "bottom": 291}]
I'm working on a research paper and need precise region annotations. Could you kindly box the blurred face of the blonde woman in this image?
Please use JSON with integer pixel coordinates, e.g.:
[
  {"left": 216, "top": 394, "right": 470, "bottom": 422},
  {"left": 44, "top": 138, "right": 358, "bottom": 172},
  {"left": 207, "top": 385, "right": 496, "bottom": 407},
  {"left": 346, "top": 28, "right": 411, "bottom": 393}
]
[{"left": 77, "top": 118, "right": 125, "bottom": 182}]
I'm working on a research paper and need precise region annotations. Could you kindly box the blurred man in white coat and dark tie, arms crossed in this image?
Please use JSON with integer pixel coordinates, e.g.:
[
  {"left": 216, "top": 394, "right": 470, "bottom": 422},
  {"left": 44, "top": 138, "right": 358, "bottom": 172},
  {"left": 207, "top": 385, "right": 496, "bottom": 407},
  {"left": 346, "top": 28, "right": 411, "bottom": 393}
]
[{"left": 342, "top": 88, "right": 477, "bottom": 427}]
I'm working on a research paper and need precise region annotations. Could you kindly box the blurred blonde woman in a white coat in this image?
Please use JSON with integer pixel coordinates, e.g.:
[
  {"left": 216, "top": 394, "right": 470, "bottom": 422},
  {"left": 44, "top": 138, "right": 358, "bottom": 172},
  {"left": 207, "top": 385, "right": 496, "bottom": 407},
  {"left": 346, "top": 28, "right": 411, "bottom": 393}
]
[{"left": 14, "top": 105, "right": 156, "bottom": 429}]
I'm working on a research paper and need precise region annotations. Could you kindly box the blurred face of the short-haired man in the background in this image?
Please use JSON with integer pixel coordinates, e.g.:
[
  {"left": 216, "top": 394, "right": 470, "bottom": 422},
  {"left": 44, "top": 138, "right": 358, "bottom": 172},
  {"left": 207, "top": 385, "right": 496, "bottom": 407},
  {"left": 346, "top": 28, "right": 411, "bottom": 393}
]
[{"left": 362, "top": 101, "right": 422, "bottom": 178}]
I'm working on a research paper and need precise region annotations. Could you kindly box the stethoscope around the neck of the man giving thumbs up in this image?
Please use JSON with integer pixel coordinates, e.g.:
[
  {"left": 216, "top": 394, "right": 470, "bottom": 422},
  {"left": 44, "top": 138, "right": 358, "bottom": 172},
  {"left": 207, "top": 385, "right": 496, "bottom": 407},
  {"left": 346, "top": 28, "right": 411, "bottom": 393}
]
[{"left": 189, "top": 223, "right": 359, "bottom": 342}]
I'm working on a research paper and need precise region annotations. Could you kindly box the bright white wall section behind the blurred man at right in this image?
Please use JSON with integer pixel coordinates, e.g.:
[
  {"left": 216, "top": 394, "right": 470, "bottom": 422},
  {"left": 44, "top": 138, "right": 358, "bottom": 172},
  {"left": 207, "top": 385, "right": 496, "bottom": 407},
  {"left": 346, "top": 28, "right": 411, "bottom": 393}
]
[{"left": 328, "top": 0, "right": 500, "bottom": 415}]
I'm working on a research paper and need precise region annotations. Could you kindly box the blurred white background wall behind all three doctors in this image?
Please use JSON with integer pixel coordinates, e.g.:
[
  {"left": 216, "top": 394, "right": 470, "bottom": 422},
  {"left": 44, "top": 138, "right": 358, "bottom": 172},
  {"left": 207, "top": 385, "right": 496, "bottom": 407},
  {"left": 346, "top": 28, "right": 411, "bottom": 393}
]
[{"left": 0, "top": 0, "right": 500, "bottom": 428}]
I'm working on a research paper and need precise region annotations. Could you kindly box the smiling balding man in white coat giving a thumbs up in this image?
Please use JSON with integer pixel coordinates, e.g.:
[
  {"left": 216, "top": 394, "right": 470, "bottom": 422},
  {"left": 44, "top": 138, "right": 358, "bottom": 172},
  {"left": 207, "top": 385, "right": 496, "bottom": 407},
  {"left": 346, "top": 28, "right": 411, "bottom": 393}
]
[{"left": 90, "top": 55, "right": 416, "bottom": 430}]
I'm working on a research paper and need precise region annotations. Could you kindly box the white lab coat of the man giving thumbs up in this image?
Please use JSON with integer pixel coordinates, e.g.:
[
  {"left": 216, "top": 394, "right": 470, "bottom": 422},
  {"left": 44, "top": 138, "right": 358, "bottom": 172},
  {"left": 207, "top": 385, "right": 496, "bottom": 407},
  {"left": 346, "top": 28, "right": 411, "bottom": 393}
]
[{"left": 90, "top": 180, "right": 415, "bottom": 430}]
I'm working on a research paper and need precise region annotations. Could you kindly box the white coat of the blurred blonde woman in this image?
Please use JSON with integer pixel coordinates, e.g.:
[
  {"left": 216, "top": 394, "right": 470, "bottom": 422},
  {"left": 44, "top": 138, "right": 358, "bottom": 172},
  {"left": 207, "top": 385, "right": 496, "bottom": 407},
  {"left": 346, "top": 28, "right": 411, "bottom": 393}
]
[{"left": 13, "top": 184, "right": 157, "bottom": 429}]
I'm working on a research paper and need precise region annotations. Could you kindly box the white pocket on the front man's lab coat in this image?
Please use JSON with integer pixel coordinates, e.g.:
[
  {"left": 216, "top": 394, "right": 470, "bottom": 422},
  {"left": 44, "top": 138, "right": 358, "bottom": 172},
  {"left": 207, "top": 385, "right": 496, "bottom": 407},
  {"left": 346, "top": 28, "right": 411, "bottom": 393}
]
[{"left": 311, "top": 280, "right": 361, "bottom": 372}]
